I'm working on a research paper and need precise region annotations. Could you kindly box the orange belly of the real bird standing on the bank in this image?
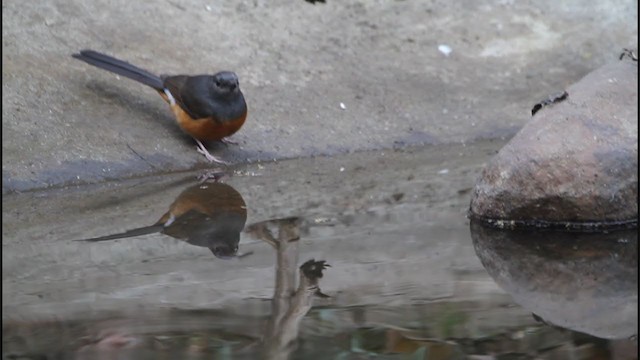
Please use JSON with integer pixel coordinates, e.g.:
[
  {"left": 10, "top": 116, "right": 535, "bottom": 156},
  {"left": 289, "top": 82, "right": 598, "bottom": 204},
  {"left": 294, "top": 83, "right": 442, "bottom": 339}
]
[{"left": 171, "top": 104, "right": 247, "bottom": 141}]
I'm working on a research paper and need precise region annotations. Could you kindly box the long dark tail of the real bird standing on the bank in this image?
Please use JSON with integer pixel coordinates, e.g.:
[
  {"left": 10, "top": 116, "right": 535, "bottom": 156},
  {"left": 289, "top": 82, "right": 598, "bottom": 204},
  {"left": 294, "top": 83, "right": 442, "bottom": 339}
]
[{"left": 71, "top": 50, "right": 163, "bottom": 91}]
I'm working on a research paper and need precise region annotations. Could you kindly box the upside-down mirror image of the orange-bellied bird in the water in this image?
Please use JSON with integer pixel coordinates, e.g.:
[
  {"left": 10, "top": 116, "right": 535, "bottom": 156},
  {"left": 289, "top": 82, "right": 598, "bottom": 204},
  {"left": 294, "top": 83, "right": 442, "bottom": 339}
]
[{"left": 75, "top": 182, "right": 248, "bottom": 259}]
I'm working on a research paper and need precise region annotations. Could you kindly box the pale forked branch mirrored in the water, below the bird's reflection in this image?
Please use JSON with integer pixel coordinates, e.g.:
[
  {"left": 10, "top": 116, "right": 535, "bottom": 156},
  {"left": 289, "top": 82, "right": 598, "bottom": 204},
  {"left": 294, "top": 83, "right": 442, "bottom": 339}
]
[{"left": 246, "top": 217, "right": 330, "bottom": 359}]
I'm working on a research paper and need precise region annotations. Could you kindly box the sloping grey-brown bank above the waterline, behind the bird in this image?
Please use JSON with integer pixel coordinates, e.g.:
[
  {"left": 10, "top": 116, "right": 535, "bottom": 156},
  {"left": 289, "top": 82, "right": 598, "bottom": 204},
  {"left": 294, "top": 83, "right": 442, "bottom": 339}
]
[{"left": 2, "top": 0, "right": 638, "bottom": 192}]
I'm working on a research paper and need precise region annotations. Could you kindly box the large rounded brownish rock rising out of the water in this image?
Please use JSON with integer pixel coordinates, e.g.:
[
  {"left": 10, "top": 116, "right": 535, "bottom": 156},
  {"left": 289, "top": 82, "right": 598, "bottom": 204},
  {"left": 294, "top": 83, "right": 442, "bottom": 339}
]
[{"left": 470, "top": 59, "right": 638, "bottom": 227}]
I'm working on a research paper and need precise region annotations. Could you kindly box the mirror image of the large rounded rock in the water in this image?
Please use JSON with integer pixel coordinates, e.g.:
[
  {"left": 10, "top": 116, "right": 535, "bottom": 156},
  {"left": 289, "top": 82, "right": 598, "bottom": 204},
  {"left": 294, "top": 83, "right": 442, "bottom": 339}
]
[{"left": 471, "top": 221, "right": 638, "bottom": 346}]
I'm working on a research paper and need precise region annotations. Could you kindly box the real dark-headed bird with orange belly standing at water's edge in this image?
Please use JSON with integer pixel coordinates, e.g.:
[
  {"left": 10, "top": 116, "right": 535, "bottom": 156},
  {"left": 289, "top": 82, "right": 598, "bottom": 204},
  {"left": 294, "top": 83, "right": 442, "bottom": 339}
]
[{"left": 71, "top": 50, "right": 247, "bottom": 164}]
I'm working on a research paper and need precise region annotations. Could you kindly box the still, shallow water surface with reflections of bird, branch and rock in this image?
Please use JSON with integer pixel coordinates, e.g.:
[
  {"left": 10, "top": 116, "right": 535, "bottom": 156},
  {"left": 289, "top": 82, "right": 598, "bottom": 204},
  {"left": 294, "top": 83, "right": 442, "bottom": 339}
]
[{"left": 2, "top": 142, "right": 638, "bottom": 359}]
